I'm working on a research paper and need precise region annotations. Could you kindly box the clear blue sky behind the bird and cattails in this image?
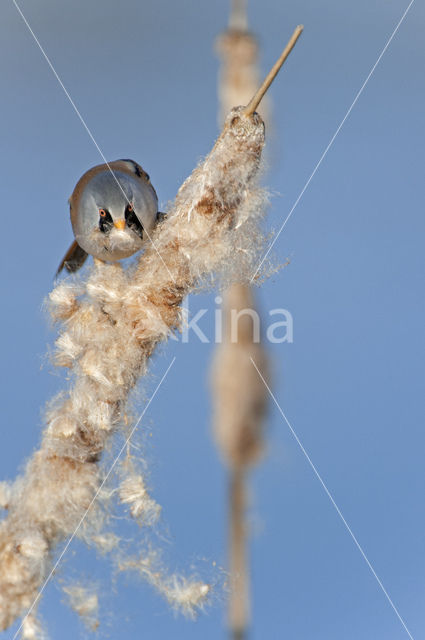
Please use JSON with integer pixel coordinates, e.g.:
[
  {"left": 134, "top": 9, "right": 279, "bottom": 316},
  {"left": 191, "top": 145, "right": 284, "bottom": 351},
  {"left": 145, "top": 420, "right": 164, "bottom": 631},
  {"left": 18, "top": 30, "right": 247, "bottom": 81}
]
[{"left": 0, "top": 0, "right": 425, "bottom": 640}]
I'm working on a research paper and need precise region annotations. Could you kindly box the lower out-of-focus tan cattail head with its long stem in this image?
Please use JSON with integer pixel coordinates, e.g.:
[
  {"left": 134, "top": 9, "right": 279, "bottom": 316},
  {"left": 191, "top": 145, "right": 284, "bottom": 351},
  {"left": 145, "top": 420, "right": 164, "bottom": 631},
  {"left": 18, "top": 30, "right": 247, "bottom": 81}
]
[{"left": 212, "top": 283, "right": 268, "bottom": 640}]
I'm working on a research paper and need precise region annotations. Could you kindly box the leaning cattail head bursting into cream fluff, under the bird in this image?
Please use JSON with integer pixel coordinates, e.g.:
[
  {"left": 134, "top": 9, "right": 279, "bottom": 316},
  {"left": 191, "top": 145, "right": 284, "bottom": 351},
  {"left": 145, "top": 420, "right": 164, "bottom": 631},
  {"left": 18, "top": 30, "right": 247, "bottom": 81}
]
[{"left": 0, "top": 108, "right": 264, "bottom": 629}]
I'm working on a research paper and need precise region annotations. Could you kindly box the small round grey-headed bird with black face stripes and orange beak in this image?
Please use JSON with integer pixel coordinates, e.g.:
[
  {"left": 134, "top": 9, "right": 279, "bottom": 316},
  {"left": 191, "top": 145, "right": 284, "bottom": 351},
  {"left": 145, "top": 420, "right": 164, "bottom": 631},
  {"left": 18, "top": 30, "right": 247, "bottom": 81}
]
[{"left": 56, "top": 160, "right": 160, "bottom": 275}]
